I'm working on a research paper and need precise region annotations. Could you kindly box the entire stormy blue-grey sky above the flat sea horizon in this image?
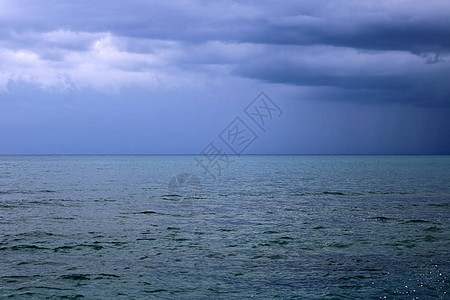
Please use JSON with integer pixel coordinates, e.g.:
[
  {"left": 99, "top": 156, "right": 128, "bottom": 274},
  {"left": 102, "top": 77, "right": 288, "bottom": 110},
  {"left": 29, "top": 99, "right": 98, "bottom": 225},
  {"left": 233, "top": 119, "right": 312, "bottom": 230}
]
[{"left": 0, "top": 0, "right": 450, "bottom": 154}]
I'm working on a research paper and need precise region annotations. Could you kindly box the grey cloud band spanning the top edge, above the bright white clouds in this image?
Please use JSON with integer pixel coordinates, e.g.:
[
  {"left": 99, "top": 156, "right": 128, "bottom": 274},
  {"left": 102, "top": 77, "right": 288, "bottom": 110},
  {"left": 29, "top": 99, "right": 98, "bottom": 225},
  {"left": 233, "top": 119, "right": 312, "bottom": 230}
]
[{"left": 5, "top": 0, "right": 450, "bottom": 52}]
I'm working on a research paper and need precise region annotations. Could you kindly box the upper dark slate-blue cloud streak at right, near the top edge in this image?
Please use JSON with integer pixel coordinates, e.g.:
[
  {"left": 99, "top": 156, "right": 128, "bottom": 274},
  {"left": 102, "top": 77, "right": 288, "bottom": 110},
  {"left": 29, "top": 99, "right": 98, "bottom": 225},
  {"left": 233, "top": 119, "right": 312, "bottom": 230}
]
[{"left": 246, "top": 16, "right": 450, "bottom": 52}]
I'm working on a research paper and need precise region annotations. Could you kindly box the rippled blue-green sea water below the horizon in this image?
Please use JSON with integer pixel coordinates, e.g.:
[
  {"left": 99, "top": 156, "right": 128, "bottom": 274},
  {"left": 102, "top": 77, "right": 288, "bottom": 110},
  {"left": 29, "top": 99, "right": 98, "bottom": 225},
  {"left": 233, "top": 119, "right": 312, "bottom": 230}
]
[{"left": 0, "top": 156, "right": 450, "bottom": 299}]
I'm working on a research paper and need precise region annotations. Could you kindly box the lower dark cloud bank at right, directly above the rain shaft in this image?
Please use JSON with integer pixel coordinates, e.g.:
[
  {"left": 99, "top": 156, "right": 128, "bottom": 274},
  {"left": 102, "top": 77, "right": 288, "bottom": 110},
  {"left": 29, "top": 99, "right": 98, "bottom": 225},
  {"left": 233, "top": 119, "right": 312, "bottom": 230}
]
[{"left": 234, "top": 46, "right": 450, "bottom": 106}]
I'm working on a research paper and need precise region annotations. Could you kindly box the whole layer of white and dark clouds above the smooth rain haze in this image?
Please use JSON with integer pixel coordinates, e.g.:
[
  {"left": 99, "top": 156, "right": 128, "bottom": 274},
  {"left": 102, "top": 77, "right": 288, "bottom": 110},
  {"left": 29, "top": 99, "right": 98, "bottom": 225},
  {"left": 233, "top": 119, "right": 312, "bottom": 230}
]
[{"left": 0, "top": 0, "right": 450, "bottom": 106}]
